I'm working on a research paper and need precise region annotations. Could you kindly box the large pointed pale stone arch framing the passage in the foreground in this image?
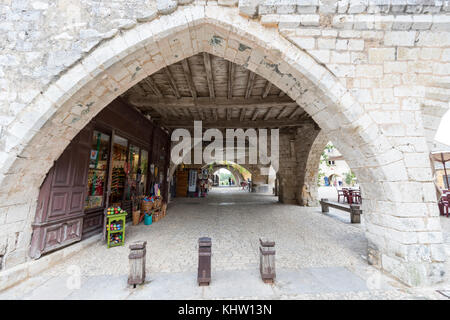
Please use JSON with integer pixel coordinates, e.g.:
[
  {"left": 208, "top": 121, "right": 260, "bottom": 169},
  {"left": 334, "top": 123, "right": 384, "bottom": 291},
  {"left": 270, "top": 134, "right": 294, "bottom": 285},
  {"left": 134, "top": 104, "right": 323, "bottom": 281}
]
[{"left": 0, "top": 5, "right": 443, "bottom": 285}]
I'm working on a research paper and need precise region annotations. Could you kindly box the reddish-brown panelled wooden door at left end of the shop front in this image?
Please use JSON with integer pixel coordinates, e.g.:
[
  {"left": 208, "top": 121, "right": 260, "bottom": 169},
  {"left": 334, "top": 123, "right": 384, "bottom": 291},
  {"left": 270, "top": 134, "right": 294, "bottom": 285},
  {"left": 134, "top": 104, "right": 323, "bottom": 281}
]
[{"left": 30, "top": 126, "right": 92, "bottom": 258}]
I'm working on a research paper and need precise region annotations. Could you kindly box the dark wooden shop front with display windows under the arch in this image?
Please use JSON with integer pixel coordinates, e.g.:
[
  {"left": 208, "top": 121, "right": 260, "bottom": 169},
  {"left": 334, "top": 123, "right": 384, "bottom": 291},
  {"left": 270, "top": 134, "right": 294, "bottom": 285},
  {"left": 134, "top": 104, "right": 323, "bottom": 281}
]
[{"left": 30, "top": 100, "right": 170, "bottom": 258}]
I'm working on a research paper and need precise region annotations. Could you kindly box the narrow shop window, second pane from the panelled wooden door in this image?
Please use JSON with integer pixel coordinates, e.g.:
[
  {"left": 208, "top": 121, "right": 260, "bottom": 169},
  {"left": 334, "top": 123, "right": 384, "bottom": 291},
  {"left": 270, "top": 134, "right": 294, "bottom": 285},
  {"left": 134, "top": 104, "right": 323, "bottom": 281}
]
[{"left": 110, "top": 136, "right": 128, "bottom": 204}]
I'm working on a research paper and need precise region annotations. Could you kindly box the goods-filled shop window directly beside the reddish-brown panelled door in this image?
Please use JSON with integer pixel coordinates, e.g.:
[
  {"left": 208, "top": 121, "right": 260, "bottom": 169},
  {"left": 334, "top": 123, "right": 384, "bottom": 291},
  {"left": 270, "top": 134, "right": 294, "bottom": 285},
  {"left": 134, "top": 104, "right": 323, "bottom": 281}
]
[{"left": 84, "top": 131, "right": 110, "bottom": 209}]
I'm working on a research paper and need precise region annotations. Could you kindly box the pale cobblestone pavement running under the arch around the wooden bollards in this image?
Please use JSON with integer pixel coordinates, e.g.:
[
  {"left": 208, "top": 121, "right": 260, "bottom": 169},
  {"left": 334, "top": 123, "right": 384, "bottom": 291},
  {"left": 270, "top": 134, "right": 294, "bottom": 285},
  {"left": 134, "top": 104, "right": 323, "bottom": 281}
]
[{"left": 0, "top": 188, "right": 450, "bottom": 299}]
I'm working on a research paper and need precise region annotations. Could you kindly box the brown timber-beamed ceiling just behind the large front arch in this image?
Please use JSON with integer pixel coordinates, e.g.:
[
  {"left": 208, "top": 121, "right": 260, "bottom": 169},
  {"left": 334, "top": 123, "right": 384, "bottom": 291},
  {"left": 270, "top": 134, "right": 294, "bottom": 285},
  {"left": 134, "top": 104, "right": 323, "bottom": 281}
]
[{"left": 121, "top": 52, "right": 313, "bottom": 128}]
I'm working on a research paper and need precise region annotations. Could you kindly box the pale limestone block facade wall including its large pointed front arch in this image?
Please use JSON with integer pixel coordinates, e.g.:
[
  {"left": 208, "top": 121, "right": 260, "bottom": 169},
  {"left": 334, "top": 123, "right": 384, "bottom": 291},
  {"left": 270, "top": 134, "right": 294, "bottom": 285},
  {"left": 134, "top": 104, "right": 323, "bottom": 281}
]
[{"left": 0, "top": 0, "right": 450, "bottom": 285}]
